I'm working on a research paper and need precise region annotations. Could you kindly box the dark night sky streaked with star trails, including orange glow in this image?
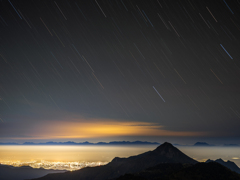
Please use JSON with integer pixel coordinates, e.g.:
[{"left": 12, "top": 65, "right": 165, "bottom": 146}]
[{"left": 0, "top": 0, "right": 240, "bottom": 143}]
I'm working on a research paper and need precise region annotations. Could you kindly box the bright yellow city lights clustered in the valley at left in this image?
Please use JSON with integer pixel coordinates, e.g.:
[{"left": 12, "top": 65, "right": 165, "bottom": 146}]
[{"left": 0, "top": 160, "right": 108, "bottom": 171}]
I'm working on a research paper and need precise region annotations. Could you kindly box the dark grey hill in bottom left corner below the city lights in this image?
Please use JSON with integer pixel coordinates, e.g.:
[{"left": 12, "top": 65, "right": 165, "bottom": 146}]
[{"left": 0, "top": 164, "right": 65, "bottom": 180}]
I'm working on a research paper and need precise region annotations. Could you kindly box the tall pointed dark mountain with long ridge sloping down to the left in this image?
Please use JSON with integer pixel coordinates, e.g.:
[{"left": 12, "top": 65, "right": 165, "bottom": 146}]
[{"left": 31, "top": 142, "right": 197, "bottom": 180}]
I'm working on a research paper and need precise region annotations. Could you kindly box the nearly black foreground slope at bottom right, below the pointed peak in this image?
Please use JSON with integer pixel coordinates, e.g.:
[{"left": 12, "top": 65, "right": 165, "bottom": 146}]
[{"left": 115, "top": 162, "right": 240, "bottom": 180}]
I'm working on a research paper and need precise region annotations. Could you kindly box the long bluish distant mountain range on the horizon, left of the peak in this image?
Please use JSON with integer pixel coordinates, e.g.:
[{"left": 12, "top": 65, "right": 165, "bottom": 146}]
[{"left": 0, "top": 141, "right": 159, "bottom": 145}]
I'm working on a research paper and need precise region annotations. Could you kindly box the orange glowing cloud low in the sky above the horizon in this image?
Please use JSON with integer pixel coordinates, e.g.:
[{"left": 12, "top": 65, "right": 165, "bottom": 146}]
[{"left": 4, "top": 119, "right": 206, "bottom": 139}]
